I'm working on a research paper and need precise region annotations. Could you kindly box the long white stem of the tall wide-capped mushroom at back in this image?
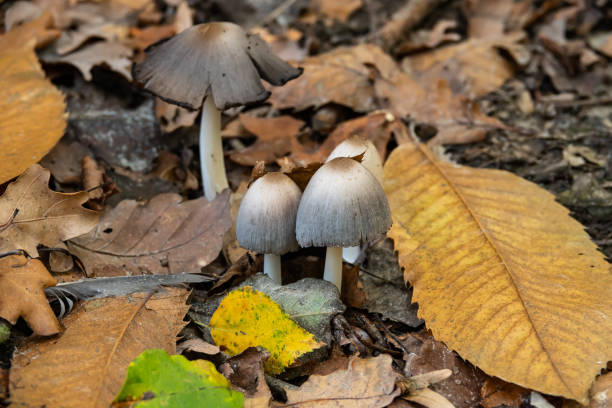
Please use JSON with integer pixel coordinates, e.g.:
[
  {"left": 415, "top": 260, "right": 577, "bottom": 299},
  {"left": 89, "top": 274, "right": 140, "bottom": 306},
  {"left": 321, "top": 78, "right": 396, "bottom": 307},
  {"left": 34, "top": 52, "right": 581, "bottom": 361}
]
[{"left": 200, "top": 96, "right": 228, "bottom": 201}]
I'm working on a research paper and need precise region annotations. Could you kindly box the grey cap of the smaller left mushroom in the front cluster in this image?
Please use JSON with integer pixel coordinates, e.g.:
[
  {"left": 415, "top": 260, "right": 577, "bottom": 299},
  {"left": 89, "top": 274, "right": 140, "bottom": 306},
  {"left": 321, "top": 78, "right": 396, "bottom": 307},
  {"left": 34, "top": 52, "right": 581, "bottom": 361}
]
[{"left": 236, "top": 173, "right": 302, "bottom": 255}]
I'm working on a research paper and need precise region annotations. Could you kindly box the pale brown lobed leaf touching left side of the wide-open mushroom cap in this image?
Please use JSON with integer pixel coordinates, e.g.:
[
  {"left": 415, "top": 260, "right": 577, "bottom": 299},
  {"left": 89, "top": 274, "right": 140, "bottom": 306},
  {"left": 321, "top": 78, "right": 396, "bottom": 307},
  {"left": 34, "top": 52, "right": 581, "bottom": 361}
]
[{"left": 52, "top": 41, "right": 132, "bottom": 81}]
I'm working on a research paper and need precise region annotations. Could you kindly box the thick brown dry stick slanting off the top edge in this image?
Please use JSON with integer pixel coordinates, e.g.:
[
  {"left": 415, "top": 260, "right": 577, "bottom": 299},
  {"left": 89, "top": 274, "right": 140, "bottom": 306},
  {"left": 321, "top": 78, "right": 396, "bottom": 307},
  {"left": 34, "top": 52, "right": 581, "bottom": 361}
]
[{"left": 375, "top": 0, "right": 442, "bottom": 51}]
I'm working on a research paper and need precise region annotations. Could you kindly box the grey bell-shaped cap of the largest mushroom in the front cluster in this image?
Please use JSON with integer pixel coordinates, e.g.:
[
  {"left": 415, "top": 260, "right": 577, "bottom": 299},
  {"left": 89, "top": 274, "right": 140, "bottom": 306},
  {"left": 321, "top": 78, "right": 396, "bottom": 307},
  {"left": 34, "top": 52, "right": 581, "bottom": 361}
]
[{"left": 296, "top": 157, "right": 392, "bottom": 247}]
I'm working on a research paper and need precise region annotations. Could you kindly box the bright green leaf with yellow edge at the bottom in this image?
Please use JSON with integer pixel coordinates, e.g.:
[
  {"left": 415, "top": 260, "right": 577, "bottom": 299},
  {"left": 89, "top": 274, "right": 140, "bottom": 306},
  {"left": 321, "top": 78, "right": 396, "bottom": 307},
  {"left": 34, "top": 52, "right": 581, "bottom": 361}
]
[{"left": 114, "top": 349, "right": 244, "bottom": 408}]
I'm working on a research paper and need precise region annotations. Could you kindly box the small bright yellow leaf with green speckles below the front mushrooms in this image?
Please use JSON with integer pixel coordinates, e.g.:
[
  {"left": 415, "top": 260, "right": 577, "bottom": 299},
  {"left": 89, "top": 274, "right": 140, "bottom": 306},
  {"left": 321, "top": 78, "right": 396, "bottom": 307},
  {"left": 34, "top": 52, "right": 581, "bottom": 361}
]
[{"left": 210, "top": 286, "right": 320, "bottom": 374}]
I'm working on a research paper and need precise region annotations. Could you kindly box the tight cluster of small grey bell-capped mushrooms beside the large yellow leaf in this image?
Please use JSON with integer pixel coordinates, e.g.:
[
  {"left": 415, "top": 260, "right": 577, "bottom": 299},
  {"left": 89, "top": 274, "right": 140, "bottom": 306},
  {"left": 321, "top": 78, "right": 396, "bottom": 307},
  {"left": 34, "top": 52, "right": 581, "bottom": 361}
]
[{"left": 236, "top": 140, "right": 391, "bottom": 290}]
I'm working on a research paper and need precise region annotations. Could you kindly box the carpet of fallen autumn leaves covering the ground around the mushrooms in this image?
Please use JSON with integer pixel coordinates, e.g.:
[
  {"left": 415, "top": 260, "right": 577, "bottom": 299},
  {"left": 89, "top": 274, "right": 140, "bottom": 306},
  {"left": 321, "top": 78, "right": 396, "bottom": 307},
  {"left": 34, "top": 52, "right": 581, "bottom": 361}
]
[{"left": 0, "top": 0, "right": 612, "bottom": 408}]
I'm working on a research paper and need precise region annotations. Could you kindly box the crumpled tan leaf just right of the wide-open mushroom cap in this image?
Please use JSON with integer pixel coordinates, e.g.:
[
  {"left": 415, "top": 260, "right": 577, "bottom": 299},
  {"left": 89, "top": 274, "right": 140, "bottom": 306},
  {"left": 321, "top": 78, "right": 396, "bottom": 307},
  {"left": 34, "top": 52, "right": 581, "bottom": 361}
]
[{"left": 270, "top": 44, "right": 397, "bottom": 112}]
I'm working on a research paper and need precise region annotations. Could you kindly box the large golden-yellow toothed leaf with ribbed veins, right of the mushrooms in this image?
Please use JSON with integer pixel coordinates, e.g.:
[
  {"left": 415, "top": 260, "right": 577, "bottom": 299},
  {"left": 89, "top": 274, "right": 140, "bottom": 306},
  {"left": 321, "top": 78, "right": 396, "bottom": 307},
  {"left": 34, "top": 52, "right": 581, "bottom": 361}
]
[{"left": 385, "top": 143, "right": 612, "bottom": 402}]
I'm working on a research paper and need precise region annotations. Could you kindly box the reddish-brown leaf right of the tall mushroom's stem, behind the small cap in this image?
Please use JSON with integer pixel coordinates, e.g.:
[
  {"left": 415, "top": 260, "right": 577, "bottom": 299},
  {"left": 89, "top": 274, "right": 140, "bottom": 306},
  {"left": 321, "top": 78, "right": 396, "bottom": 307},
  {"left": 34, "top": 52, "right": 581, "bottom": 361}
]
[{"left": 230, "top": 115, "right": 304, "bottom": 166}]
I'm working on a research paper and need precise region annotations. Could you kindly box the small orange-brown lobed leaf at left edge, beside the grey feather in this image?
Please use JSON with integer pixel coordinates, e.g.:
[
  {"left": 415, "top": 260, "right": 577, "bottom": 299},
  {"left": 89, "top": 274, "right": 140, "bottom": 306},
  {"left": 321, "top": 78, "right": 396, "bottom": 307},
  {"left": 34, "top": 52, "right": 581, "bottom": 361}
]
[{"left": 0, "top": 255, "right": 60, "bottom": 336}]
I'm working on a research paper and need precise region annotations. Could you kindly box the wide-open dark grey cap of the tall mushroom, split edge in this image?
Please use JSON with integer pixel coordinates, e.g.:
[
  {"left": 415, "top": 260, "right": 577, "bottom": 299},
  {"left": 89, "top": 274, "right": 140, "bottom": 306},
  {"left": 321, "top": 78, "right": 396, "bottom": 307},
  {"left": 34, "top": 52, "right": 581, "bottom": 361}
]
[{"left": 132, "top": 22, "right": 302, "bottom": 110}]
